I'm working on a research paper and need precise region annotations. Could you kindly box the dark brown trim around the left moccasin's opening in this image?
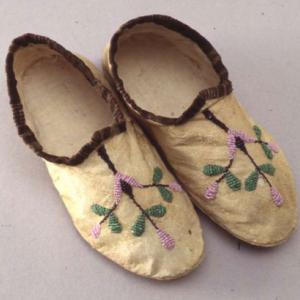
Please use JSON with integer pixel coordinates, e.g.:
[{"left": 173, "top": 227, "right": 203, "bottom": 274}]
[{"left": 6, "top": 33, "right": 126, "bottom": 165}]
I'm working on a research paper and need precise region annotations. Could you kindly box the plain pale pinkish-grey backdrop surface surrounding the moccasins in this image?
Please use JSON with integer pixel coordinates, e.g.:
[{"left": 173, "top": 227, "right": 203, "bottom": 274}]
[{"left": 0, "top": 0, "right": 300, "bottom": 300}]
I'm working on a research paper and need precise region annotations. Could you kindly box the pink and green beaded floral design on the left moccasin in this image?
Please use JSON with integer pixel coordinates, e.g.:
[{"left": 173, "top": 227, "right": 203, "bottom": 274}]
[{"left": 91, "top": 146, "right": 182, "bottom": 250}]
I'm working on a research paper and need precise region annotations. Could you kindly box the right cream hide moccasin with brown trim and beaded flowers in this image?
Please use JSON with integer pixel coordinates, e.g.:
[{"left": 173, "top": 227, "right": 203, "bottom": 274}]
[{"left": 105, "top": 15, "right": 297, "bottom": 247}]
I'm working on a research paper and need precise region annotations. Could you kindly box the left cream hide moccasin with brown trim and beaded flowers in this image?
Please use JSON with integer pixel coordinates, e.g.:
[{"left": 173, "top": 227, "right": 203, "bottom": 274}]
[{"left": 6, "top": 34, "right": 204, "bottom": 280}]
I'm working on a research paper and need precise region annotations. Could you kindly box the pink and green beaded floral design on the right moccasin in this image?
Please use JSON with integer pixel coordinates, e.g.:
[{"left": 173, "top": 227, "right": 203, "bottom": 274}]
[{"left": 203, "top": 109, "right": 283, "bottom": 206}]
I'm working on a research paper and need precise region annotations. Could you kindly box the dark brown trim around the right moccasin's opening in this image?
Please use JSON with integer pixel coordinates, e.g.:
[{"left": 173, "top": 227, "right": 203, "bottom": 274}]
[{"left": 109, "top": 15, "right": 232, "bottom": 125}]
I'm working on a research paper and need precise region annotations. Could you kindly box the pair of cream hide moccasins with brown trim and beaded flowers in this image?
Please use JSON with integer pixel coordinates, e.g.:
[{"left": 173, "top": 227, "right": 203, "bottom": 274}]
[{"left": 6, "top": 15, "right": 297, "bottom": 280}]
